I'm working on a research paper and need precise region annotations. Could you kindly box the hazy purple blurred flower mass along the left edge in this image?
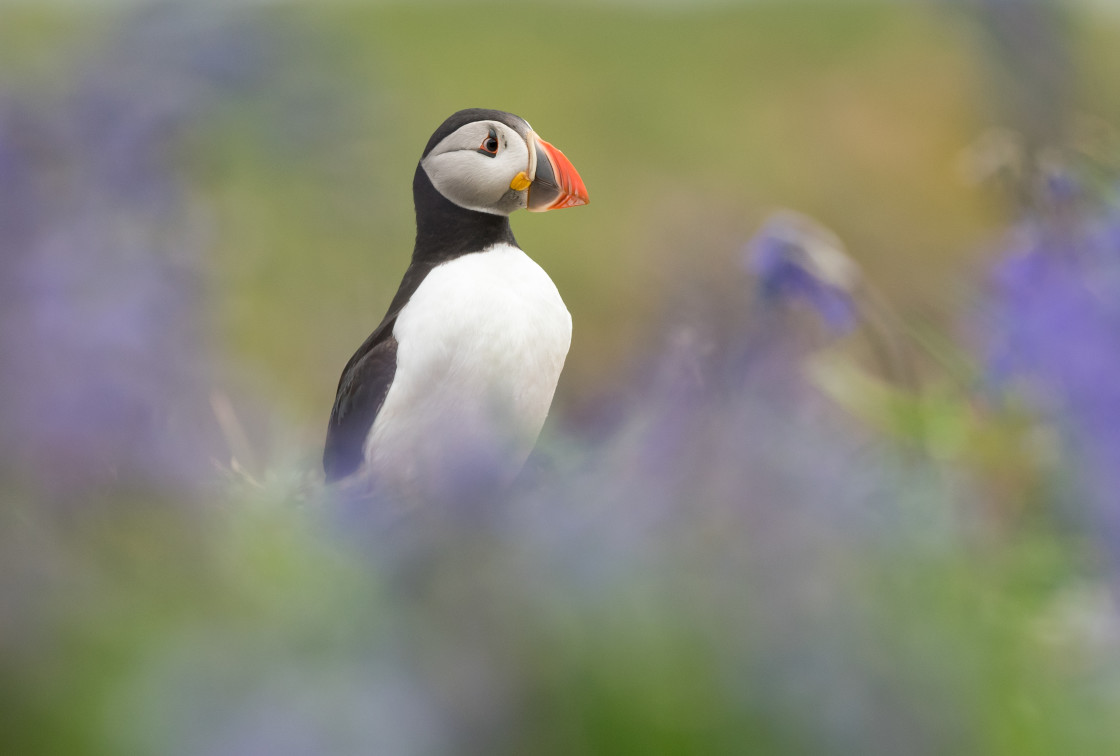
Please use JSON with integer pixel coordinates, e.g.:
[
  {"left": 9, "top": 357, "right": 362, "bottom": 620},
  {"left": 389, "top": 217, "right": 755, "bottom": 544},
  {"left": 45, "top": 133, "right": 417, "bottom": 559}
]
[{"left": 0, "top": 9, "right": 302, "bottom": 498}]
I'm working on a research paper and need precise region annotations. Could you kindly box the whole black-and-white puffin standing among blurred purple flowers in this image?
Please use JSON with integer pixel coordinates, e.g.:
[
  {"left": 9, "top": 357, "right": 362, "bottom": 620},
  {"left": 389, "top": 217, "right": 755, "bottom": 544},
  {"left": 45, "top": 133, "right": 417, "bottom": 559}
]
[{"left": 323, "top": 109, "right": 588, "bottom": 491}]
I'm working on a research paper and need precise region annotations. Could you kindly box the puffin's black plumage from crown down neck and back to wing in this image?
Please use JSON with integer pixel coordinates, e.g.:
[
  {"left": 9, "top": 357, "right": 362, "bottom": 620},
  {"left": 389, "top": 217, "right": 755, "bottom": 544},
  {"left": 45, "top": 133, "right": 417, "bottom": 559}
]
[{"left": 323, "top": 108, "right": 519, "bottom": 483}]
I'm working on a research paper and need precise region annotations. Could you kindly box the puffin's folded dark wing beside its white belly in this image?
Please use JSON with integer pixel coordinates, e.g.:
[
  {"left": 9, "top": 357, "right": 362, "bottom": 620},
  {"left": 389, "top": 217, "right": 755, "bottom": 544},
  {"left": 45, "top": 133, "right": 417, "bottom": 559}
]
[{"left": 323, "top": 317, "right": 396, "bottom": 483}]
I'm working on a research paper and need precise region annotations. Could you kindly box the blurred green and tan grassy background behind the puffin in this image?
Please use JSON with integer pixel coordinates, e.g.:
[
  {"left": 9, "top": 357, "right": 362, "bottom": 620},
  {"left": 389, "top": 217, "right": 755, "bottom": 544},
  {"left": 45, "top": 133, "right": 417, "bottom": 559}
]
[{"left": 10, "top": 2, "right": 1120, "bottom": 454}]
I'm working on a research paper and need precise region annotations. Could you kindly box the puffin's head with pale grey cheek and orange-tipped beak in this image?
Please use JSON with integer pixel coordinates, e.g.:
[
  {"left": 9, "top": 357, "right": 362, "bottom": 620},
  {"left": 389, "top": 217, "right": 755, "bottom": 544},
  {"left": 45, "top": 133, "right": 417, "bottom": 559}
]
[{"left": 420, "top": 108, "right": 588, "bottom": 215}]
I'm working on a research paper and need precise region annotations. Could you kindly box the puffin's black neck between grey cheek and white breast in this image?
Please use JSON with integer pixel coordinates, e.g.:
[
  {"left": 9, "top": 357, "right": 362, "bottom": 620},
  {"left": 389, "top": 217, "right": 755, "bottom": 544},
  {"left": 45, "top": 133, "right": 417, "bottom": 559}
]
[{"left": 412, "top": 166, "right": 517, "bottom": 264}]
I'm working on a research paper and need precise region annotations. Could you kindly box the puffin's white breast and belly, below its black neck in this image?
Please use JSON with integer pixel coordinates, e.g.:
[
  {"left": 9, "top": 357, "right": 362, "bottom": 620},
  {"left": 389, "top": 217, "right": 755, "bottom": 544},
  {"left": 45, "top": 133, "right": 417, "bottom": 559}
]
[{"left": 364, "top": 244, "right": 571, "bottom": 484}]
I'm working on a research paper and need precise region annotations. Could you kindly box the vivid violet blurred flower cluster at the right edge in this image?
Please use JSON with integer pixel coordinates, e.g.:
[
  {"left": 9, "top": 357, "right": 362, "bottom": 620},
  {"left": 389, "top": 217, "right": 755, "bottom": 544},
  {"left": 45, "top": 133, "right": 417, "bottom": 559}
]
[{"left": 987, "top": 203, "right": 1120, "bottom": 571}]
